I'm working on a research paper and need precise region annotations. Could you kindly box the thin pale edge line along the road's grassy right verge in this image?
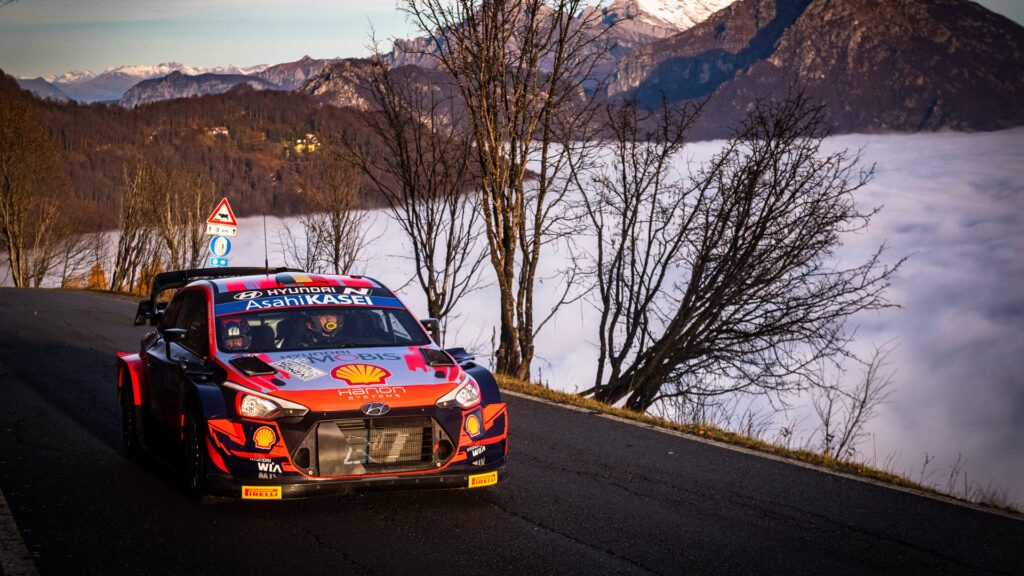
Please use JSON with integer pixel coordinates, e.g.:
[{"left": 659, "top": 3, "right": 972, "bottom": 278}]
[{"left": 502, "top": 388, "right": 1024, "bottom": 522}]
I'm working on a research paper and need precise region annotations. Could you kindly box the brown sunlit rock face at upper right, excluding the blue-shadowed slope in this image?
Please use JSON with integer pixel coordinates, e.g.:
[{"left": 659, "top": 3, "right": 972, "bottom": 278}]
[{"left": 709, "top": 0, "right": 1024, "bottom": 132}]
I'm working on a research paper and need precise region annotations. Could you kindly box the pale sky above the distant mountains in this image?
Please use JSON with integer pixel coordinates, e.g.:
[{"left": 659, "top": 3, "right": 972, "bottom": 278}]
[{"left": 0, "top": 0, "right": 1024, "bottom": 77}]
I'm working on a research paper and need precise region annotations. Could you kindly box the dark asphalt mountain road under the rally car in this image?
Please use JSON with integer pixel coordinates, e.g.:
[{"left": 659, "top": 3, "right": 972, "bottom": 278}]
[{"left": 0, "top": 289, "right": 1024, "bottom": 576}]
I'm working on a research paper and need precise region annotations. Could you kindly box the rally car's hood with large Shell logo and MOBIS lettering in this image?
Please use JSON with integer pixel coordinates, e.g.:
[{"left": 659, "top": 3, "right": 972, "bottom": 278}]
[{"left": 218, "top": 346, "right": 464, "bottom": 412}]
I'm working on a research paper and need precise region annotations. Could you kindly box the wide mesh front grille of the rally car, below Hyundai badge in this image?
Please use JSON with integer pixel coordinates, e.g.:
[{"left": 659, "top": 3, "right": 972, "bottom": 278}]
[{"left": 293, "top": 416, "right": 449, "bottom": 477}]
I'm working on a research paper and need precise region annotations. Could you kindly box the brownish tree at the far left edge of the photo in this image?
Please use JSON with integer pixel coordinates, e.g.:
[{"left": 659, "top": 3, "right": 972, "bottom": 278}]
[{"left": 0, "top": 87, "right": 69, "bottom": 287}]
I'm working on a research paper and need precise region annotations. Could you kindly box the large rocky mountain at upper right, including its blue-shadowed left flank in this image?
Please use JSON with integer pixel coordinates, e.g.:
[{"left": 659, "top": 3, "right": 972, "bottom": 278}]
[{"left": 608, "top": 0, "right": 1024, "bottom": 137}]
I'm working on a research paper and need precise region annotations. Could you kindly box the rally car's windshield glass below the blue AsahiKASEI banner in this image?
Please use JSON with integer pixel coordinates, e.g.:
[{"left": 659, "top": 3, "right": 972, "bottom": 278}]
[{"left": 216, "top": 305, "right": 430, "bottom": 354}]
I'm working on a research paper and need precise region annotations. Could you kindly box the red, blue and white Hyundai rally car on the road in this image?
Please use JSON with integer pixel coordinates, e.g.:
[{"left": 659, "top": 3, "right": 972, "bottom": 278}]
[{"left": 118, "top": 269, "right": 508, "bottom": 499}]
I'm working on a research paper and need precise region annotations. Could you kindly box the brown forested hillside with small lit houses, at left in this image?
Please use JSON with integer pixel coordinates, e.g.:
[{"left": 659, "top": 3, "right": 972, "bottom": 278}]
[{"left": 0, "top": 75, "right": 376, "bottom": 228}]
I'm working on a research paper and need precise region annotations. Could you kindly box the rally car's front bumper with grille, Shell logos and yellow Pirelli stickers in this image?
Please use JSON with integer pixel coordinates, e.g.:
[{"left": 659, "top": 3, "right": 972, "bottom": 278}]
[{"left": 199, "top": 403, "right": 508, "bottom": 499}]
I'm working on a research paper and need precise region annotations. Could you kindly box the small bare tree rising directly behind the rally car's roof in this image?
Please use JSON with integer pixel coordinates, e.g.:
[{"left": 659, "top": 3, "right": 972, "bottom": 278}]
[{"left": 282, "top": 153, "right": 372, "bottom": 274}]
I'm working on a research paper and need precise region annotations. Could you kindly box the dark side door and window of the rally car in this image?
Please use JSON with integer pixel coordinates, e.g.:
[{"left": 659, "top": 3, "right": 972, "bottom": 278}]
[{"left": 147, "top": 290, "right": 209, "bottom": 436}]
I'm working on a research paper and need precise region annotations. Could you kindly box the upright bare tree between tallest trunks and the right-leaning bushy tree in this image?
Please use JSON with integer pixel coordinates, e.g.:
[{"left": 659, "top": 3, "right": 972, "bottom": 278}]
[{"left": 579, "top": 100, "right": 702, "bottom": 393}]
